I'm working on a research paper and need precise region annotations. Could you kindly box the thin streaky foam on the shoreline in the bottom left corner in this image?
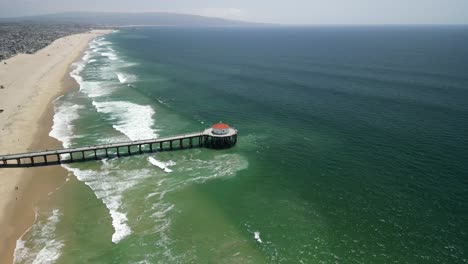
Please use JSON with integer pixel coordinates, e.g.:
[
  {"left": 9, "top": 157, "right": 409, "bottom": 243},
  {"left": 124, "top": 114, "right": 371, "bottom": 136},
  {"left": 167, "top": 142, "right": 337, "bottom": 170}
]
[{"left": 13, "top": 209, "right": 65, "bottom": 264}]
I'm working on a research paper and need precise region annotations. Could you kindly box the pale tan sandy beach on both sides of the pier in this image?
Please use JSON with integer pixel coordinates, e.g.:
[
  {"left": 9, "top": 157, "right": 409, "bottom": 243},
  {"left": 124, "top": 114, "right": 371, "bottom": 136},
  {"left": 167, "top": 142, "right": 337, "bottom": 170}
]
[{"left": 0, "top": 30, "right": 111, "bottom": 263}]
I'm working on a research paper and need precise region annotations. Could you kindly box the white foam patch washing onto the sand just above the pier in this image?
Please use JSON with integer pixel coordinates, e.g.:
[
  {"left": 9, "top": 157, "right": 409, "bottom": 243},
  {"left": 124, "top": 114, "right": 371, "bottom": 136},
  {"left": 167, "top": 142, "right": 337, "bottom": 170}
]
[{"left": 49, "top": 101, "right": 83, "bottom": 148}]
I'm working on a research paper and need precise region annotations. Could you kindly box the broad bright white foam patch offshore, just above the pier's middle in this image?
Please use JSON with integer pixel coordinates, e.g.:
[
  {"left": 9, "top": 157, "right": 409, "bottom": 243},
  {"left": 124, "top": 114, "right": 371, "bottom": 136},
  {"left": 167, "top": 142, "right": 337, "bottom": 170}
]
[{"left": 93, "top": 101, "right": 158, "bottom": 140}]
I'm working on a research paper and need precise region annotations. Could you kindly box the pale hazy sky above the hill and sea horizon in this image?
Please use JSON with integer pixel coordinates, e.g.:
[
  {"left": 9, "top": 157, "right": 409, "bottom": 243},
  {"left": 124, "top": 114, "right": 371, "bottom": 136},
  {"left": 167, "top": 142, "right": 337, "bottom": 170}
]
[{"left": 0, "top": 0, "right": 468, "bottom": 24}]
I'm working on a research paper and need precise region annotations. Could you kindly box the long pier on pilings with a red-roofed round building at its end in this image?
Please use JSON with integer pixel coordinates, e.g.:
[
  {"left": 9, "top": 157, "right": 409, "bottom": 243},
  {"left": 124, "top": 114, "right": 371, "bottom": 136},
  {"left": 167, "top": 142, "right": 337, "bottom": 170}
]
[{"left": 0, "top": 124, "right": 237, "bottom": 168}]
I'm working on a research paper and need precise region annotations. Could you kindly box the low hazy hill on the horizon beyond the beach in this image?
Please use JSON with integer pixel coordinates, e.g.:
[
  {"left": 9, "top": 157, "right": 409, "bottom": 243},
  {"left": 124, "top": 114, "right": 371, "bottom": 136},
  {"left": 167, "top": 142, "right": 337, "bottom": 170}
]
[{"left": 0, "top": 12, "right": 258, "bottom": 26}]
